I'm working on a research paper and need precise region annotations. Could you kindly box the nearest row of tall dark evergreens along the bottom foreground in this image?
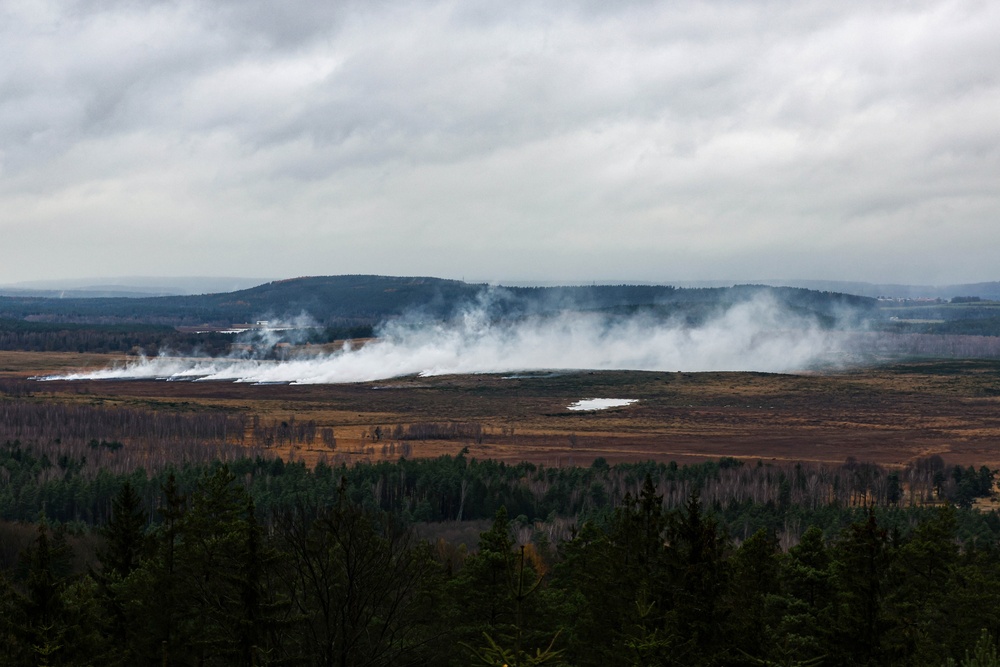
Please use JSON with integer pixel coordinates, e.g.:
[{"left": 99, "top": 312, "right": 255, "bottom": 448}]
[{"left": 0, "top": 466, "right": 1000, "bottom": 667}]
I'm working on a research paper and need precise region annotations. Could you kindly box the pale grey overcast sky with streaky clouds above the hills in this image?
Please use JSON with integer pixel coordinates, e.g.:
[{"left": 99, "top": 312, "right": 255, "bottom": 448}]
[{"left": 0, "top": 0, "right": 1000, "bottom": 284}]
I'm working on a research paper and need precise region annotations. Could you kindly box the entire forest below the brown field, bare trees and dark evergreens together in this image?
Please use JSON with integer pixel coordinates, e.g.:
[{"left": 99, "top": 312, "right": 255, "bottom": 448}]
[{"left": 0, "top": 384, "right": 1000, "bottom": 666}]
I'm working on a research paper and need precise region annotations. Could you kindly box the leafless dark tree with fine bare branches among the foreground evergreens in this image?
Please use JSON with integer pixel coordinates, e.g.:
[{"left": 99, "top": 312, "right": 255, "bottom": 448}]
[{"left": 278, "top": 486, "right": 438, "bottom": 665}]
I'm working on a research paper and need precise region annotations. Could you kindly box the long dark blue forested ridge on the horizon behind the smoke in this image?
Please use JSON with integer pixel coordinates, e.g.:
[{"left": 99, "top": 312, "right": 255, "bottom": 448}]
[{"left": 0, "top": 275, "right": 876, "bottom": 326}]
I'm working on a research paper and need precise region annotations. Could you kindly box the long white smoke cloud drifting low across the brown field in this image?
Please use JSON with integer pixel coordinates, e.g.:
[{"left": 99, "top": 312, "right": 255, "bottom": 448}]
[{"left": 45, "top": 295, "right": 841, "bottom": 384}]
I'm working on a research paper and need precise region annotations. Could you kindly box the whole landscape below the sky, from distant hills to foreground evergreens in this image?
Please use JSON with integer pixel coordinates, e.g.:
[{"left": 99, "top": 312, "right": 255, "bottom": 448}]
[{"left": 0, "top": 276, "right": 1000, "bottom": 665}]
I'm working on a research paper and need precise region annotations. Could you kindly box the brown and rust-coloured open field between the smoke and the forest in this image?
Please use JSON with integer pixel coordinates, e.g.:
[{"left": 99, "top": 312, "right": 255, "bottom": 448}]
[{"left": 0, "top": 352, "right": 1000, "bottom": 467}]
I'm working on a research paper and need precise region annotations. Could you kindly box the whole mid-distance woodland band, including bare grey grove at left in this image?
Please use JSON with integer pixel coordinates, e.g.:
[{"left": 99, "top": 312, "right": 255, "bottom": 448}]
[{"left": 0, "top": 388, "right": 994, "bottom": 537}]
